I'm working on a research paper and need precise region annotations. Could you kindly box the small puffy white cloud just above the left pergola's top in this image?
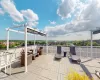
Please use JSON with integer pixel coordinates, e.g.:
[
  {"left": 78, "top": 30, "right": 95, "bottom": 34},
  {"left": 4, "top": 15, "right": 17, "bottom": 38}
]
[{"left": 21, "top": 9, "right": 39, "bottom": 21}]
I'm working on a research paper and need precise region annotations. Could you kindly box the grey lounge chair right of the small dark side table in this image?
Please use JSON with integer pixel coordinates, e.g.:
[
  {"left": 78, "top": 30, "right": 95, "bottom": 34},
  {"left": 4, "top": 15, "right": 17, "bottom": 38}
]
[{"left": 70, "top": 46, "right": 81, "bottom": 63}]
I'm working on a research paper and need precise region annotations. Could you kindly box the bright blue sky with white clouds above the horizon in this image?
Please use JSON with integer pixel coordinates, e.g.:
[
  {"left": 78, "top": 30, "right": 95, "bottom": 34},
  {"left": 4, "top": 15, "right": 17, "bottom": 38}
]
[{"left": 0, "top": 0, "right": 100, "bottom": 40}]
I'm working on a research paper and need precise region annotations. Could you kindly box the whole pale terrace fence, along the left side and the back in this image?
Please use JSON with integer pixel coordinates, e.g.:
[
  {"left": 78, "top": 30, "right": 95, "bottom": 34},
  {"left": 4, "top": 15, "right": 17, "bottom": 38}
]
[{"left": 0, "top": 46, "right": 100, "bottom": 69}]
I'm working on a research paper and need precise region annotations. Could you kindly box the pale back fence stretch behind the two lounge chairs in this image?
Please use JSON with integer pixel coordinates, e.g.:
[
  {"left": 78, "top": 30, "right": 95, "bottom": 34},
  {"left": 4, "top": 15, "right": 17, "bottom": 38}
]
[{"left": 43, "top": 46, "right": 100, "bottom": 58}]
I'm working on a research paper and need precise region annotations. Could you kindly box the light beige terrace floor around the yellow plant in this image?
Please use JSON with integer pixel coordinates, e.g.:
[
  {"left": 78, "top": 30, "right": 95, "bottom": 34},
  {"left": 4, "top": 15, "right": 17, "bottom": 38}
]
[{"left": 0, "top": 54, "right": 100, "bottom": 80}]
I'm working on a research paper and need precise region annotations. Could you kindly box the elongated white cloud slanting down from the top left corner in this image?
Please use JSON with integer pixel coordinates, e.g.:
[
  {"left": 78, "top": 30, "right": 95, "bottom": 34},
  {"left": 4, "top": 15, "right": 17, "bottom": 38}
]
[{"left": 0, "top": 0, "right": 24, "bottom": 22}]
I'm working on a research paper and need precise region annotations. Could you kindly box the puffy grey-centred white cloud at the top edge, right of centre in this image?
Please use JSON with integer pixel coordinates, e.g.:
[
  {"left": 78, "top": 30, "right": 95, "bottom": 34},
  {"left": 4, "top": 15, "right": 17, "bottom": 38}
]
[{"left": 57, "top": 0, "right": 85, "bottom": 19}]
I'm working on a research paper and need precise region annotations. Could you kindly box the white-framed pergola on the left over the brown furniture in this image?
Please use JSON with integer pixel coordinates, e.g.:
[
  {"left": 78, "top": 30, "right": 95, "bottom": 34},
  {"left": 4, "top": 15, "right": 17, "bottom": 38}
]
[{"left": 6, "top": 24, "right": 48, "bottom": 72}]
